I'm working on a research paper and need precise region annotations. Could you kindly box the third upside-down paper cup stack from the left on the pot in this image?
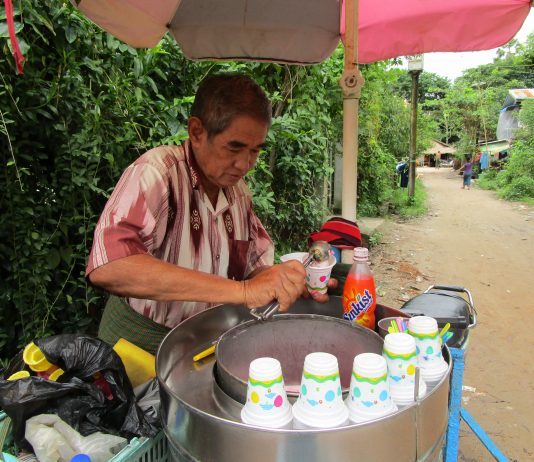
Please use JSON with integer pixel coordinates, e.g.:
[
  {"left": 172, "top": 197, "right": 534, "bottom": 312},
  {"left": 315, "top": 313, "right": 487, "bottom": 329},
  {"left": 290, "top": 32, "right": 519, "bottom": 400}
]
[{"left": 346, "top": 353, "right": 397, "bottom": 423}]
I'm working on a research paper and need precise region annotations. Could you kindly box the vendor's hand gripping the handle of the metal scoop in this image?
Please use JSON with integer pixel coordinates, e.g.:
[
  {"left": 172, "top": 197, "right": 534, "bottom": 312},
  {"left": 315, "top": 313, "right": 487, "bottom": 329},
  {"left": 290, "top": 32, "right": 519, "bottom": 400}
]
[{"left": 243, "top": 261, "right": 306, "bottom": 312}]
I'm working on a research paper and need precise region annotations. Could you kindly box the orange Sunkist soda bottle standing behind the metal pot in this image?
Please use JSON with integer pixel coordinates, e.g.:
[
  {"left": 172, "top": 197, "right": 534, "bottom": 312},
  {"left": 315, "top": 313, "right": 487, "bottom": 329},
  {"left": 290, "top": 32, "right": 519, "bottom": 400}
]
[{"left": 342, "top": 247, "right": 376, "bottom": 330}]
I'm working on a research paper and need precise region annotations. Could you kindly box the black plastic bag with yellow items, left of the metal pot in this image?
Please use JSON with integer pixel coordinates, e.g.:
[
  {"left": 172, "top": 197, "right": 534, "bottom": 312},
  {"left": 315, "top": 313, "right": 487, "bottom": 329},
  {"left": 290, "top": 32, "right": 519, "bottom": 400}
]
[{"left": 0, "top": 334, "right": 158, "bottom": 448}]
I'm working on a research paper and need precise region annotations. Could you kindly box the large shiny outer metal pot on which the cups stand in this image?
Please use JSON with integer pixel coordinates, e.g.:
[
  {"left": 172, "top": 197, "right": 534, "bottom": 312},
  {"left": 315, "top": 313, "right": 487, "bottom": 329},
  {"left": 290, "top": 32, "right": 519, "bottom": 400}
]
[{"left": 156, "top": 297, "right": 451, "bottom": 462}]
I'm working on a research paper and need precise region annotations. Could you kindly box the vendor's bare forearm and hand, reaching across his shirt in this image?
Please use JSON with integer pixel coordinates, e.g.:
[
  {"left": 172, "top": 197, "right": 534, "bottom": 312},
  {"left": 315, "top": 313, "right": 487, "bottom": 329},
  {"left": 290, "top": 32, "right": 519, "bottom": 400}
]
[{"left": 88, "top": 254, "right": 306, "bottom": 311}]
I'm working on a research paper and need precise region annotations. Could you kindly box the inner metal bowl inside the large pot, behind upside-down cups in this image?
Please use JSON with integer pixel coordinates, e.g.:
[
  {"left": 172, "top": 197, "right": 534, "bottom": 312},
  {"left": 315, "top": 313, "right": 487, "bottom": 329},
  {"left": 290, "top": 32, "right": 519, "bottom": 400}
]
[{"left": 215, "top": 314, "right": 384, "bottom": 404}]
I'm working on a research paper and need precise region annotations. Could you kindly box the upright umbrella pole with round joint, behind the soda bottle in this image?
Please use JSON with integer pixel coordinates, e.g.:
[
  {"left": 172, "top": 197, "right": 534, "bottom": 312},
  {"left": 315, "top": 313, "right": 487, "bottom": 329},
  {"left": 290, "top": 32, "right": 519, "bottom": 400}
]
[{"left": 339, "top": 0, "right": 364, "bottom": 263}]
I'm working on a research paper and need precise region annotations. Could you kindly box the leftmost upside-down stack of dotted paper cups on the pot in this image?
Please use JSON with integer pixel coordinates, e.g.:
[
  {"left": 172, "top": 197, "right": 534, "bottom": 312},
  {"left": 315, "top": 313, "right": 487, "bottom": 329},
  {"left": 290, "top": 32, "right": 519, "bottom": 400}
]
[{"left": 241, "top": 358, "right": 293, "bottom": 428}]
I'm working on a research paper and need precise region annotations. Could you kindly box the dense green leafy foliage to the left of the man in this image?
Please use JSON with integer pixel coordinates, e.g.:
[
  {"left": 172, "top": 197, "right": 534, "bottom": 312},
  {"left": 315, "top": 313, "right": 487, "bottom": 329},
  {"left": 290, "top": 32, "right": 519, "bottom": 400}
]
[{"left": 0, "top": 1, "right": 197, "bottom": 357}]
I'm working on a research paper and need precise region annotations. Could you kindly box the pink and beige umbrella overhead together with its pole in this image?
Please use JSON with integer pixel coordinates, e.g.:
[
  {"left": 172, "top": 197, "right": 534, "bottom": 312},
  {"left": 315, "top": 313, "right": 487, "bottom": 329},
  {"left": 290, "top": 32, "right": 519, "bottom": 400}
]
[{"left": 72, "top": 0, "right": 531, "bottom": 251}]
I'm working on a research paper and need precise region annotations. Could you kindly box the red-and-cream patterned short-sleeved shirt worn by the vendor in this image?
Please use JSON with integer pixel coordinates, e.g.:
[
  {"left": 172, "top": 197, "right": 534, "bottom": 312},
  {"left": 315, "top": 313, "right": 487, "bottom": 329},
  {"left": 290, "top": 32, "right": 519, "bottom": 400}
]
[{"left": 86, "top": 141, "right": 274, "bottom": 328}]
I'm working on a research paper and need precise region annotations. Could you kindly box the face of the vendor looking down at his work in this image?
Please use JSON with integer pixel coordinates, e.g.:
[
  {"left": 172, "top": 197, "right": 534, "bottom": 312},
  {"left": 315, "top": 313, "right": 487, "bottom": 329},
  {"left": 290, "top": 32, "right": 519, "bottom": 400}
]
[{"left": 189, "top": 116, "right": 269, "bottom": 191}]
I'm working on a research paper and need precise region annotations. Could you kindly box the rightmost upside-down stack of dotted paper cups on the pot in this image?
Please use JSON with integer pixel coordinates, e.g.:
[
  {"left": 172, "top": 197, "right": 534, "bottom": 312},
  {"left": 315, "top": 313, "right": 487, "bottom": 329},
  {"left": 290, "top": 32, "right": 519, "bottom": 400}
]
[{"left": 408, "top": 316, "right": 449, "bottom": 386}]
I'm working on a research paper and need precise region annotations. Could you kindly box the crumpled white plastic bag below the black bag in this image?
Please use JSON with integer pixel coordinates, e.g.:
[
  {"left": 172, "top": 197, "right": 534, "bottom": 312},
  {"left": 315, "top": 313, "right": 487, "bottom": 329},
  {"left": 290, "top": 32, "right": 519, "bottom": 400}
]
[{"left": 24, "top": 414, "right": 128, "bottom": 462}]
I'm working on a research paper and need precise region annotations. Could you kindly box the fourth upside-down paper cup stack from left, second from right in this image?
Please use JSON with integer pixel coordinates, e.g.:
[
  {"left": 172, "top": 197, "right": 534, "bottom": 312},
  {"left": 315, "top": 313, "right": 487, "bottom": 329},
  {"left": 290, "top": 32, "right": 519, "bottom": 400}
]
[{"left": 383, "top": 332, "right": 426, "bottom": 406}]
